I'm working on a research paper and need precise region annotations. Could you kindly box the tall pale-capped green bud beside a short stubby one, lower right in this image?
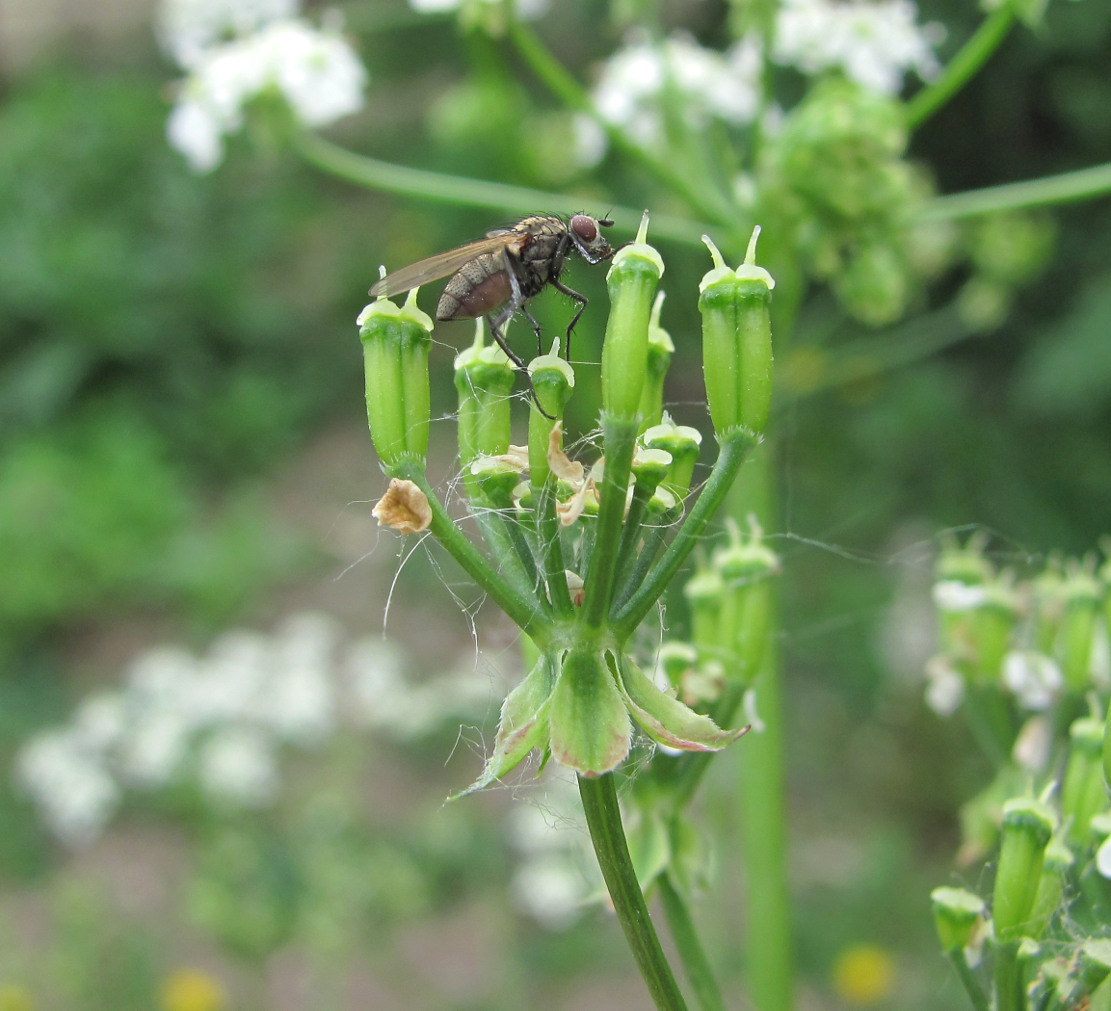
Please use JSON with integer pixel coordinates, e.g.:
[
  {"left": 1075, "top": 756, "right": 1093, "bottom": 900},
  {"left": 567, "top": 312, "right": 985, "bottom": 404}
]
[{"left": 992, "top": 798, "right": 1057, "bottom": 942}]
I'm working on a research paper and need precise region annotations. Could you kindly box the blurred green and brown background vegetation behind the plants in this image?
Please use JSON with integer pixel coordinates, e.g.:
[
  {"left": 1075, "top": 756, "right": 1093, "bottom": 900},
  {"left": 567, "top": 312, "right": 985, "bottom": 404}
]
[{"left": 0, "top": 0, "right": 1111, "bottom": 1011}]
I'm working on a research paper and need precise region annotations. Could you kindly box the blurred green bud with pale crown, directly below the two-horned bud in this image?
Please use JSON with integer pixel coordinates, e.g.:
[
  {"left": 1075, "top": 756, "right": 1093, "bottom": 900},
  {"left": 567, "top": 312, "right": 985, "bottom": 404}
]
[{"left": 713, "top": 515, "right": 780, "bottom": 684}]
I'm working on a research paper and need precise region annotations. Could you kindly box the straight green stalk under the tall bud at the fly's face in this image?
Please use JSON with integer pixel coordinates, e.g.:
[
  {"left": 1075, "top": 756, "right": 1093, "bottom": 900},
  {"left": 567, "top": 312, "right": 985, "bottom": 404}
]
[{"left": 581, "top": 418, "right": 638, "bottom": 629}]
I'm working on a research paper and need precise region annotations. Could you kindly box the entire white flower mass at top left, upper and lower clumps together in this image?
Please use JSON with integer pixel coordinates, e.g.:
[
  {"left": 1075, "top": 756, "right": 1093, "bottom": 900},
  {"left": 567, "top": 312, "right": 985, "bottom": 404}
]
[{"left": 160, "top": 0, "right": 367, "bottom": 172}]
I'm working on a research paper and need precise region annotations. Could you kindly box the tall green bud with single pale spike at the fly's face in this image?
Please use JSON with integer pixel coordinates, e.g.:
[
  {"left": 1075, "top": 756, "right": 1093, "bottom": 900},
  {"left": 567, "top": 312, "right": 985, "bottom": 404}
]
[{"left": 602, "top": 211, "right": 663, "bottom": 421}]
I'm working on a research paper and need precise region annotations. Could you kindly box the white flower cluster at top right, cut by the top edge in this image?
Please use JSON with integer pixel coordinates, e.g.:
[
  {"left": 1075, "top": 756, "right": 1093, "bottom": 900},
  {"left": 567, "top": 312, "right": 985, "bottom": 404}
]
[{"left": 772, "top": 0, "right": 945, "bottom": 94}]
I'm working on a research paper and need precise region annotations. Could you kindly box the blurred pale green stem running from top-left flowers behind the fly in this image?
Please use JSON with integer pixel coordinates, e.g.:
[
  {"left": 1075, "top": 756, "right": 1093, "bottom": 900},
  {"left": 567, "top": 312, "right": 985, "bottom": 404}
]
[{"left": 293, "top": 133, "right": 712, "bottom": 246}]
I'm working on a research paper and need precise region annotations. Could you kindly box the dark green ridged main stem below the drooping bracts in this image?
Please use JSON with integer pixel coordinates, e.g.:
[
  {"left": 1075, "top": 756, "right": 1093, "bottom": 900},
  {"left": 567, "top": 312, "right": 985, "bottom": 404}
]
[{"left": 578, "top": 773, "right": 687, "bottom": 1011}]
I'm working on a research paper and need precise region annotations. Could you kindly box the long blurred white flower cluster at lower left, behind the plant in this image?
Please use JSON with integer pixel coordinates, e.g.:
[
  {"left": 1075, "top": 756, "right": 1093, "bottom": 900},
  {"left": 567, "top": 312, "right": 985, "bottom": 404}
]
[{"left": 16, "top": 612, "right": 489, "bottom": 848}]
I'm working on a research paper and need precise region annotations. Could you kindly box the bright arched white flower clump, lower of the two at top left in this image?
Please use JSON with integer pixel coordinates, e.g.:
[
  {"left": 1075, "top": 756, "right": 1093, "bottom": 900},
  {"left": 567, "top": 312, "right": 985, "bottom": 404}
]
[{"left": 167, "top": 19, "right": 367, "bottom": 172}]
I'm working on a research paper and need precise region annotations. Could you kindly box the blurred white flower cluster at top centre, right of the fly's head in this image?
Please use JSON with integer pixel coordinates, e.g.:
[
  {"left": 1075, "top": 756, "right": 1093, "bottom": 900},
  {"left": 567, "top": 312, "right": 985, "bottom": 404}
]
[{"left": 575, "top": 31, "right": 761, "bottom": 164}]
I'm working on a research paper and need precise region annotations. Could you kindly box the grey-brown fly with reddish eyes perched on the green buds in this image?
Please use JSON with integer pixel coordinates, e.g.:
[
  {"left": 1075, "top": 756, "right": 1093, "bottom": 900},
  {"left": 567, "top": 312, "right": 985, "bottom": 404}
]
[{"left": 370, "top": 214, "right": 614, "bottom": 407}]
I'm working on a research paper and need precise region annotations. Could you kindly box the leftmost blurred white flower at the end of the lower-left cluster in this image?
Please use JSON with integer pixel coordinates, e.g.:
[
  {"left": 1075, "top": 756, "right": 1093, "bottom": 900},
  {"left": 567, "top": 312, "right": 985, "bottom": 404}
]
[{"left": 16, "top": 729, "right": 120, "bottom": 849}]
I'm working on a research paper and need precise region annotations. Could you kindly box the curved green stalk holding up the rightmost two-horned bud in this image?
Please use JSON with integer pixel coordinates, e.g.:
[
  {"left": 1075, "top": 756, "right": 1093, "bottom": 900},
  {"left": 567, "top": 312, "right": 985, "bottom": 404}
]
[{"left": 607, "top": 429, "right": 757, "bottom": 641}]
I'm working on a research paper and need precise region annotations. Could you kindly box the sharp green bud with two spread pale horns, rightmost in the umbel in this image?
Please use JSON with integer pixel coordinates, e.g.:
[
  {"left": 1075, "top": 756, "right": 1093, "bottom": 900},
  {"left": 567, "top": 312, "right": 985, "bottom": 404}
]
[{"left": 698, "top": 228, "right": 775, "bottom": 437}]
